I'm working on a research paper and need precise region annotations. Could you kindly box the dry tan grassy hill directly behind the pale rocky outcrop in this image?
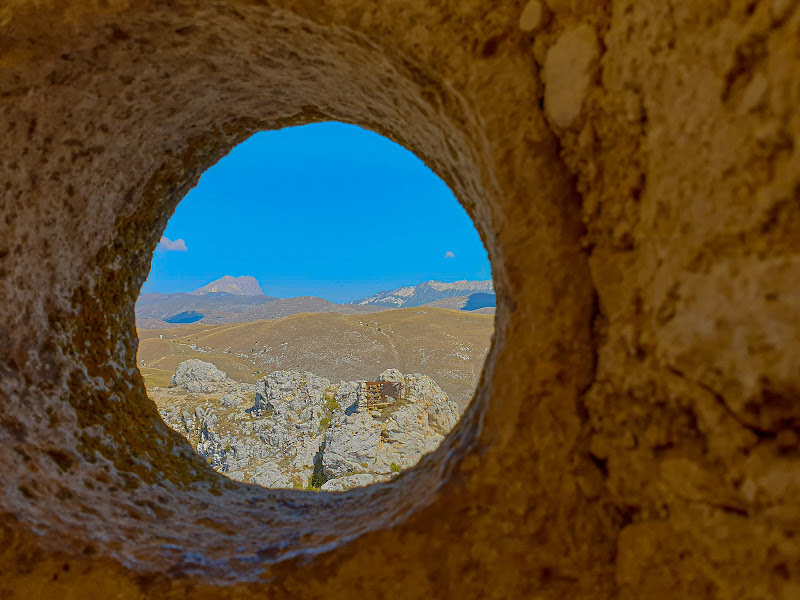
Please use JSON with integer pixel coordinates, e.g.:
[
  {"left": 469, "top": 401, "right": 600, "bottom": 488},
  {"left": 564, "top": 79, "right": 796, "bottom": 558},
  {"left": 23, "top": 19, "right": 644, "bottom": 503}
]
[{"left": 138, "top": 307, "right": 494, "bottom": 409}]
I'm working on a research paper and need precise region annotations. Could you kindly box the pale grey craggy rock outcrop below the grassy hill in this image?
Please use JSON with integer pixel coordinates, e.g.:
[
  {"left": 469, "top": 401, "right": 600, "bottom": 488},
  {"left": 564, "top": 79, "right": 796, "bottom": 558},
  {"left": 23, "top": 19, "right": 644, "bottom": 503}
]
[{"left": 149, "top": 360, "right": 459, "bottom": 491}]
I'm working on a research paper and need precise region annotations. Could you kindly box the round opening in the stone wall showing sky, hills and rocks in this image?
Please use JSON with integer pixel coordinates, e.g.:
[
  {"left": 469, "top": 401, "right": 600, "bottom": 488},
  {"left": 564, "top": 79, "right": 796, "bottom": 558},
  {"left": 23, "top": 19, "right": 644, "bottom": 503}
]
[{"left": 136, "top": 123, "right": 495, "bottom": 491}]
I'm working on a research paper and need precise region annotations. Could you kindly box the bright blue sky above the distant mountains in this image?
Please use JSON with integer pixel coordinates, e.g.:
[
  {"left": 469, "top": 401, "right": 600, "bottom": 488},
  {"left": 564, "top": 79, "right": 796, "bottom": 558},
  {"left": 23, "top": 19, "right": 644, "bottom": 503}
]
[{"left": 142, "top": 123, "right": 491, "bottom": 302}]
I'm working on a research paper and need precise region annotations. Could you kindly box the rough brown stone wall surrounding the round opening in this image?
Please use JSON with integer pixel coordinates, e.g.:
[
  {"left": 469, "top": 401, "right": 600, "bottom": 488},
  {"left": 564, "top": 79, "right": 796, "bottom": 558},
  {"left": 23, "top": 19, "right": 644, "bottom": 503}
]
[{"left": 0, "top": 0, "right": 800, "bottom": 600}]
